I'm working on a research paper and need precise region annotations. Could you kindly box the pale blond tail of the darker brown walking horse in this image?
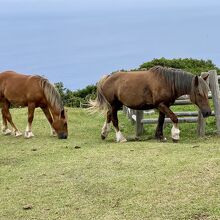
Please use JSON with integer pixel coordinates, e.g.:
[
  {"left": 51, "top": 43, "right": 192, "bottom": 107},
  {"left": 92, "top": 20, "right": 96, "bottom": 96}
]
[{"left": 89, "top": 75, "right": 111, "bottom": 112}]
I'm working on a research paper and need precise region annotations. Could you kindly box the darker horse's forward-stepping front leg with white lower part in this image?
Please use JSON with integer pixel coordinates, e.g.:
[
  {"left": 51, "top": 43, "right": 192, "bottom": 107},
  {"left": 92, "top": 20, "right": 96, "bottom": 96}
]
[{"left": 158, "top": 103, "right": 180, "bottom": 142}]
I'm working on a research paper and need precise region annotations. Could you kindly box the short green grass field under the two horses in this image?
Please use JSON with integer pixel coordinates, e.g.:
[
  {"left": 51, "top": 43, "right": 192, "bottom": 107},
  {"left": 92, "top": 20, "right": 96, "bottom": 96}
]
[{"left": 0, "top": 109, "right": 220, "bottom": 220}]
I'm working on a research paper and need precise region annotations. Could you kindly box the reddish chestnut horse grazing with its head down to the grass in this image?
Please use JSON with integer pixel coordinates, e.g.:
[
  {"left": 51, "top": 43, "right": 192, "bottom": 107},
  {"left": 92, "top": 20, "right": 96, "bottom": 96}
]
[{"left": 0, "top": 71, "right": 68, "bottom": 139}]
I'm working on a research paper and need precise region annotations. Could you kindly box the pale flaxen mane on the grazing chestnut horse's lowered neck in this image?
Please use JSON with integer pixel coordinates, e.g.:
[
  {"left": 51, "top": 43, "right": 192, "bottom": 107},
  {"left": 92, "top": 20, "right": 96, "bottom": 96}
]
[{"left": 37, "top": 76, "right": 63, "bottom": 111}]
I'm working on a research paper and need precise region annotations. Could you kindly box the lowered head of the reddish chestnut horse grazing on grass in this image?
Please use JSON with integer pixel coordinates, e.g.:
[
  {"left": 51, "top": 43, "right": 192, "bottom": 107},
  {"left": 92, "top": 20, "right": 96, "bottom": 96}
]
[{"left": 52, "top": 109, "right": 68, "bottom": 139}]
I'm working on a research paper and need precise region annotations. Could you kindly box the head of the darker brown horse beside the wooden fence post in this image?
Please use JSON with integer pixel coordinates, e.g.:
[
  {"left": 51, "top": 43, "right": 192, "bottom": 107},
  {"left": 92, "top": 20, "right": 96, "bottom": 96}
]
[{"left": 190, "top": 76, "right": 212, "bottom": 117}]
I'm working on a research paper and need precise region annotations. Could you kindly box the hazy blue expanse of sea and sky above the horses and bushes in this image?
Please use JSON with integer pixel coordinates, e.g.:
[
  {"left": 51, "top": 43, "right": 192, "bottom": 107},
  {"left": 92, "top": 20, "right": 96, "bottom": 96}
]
[{"left": 0, "top": 0, "right": 220, "bottom": 90}]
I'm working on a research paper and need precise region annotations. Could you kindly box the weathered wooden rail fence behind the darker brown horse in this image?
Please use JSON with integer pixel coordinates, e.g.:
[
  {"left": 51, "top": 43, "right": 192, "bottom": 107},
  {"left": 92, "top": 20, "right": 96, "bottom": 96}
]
[{"left": 123, "top": 70, "right": 220, "bottom": 136}]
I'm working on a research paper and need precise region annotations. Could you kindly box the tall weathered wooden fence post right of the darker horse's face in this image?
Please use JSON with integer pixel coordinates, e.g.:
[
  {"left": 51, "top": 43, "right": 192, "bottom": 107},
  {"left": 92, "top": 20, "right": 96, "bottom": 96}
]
[{"left": 209, "top": 70, "right": 220, "bottom": 135}]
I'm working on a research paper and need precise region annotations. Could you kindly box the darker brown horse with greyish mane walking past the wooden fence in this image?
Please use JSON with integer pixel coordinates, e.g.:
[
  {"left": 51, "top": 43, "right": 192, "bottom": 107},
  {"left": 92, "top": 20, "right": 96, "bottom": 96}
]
[{"left": 90, "top": 66, "right": 211, "bottom": 142}]
